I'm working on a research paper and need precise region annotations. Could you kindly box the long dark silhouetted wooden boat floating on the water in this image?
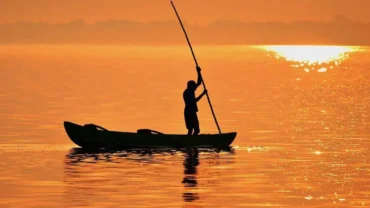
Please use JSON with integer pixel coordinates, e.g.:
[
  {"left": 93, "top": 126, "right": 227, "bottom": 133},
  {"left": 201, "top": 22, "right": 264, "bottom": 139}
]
[{"left": 64, "top": 121, "right": 236, "bottom": 149}]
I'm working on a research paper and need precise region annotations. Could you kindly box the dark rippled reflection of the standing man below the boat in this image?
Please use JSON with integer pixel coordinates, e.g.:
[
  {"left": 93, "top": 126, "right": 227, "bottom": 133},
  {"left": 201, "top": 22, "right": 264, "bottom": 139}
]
[{"left": 182, "top": 149, "right": 199, "bottom": 202}]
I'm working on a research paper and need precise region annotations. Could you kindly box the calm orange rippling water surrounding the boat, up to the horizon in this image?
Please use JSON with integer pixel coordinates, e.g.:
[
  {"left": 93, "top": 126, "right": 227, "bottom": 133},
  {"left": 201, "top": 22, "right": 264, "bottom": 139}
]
[{"left": 0, "top": 45, "right": 370, "bottom": 207}]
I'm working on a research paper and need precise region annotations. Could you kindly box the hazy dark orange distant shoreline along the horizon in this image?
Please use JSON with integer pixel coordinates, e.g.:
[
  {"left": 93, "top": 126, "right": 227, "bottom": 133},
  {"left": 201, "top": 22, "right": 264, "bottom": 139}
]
[{"left": 0, "top": 17, "right": 370, "bottom": 46}]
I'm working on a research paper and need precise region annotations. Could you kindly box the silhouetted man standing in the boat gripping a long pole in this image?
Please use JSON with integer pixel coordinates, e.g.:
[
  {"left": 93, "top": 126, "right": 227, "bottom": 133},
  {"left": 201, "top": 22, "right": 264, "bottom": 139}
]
[{"left": 183, "top": 66, "right": 207, "bottom": 135}]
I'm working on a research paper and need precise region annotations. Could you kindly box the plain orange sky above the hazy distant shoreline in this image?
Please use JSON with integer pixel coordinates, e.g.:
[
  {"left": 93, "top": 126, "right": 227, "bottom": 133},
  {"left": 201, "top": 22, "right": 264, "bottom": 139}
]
[{"left": 0, "top": 0, "right": 370, "bottom": 24}]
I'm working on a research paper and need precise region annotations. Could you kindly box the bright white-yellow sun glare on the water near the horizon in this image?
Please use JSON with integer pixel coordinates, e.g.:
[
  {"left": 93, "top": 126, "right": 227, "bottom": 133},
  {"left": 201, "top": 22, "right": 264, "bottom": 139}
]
[{"left": 261, "top": 46, "right": 357, "bottom": 72}]
